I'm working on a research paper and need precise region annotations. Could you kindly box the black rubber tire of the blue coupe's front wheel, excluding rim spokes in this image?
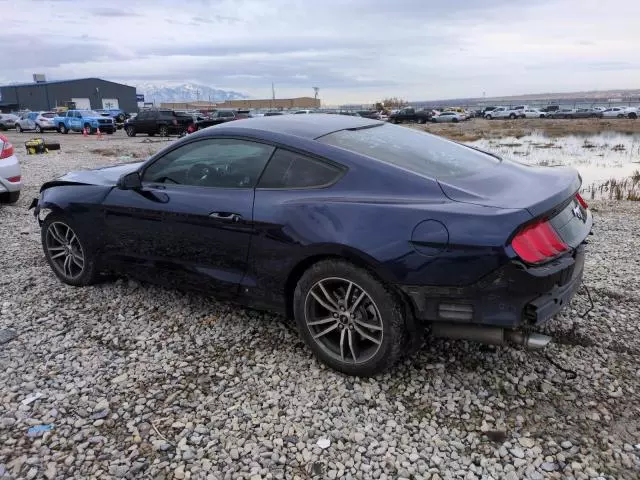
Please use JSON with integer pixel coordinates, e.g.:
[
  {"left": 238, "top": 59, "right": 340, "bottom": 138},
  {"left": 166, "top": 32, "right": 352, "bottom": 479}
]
[{"left": 40, "top": 213, "right": 99, "bottom": 287}]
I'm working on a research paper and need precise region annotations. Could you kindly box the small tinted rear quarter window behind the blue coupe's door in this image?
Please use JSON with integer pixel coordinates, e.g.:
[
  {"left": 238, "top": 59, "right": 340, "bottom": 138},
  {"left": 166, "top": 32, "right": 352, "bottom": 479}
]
[{"left": 258, "top": 148, "right": 344, "bottom": 189}]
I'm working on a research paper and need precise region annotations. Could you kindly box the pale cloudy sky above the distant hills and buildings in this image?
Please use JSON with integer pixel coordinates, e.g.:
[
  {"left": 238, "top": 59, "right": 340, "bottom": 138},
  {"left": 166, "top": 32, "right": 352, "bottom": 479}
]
[{"left": 0, "top": 0, "right": 640, "bottom": 104}]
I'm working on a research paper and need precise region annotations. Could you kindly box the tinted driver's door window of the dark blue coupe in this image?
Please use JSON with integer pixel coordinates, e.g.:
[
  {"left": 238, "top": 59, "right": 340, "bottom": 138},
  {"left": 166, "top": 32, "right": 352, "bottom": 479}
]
[{"left": 142, "top": 138, "right": 274, "bottom": 188}]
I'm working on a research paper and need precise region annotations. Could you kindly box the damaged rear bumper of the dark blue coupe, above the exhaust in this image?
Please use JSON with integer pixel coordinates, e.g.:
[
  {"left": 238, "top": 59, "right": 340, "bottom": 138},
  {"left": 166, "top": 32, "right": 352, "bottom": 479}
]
[{"left": 401, "top": 243, "right": 585, "bottom": 328}]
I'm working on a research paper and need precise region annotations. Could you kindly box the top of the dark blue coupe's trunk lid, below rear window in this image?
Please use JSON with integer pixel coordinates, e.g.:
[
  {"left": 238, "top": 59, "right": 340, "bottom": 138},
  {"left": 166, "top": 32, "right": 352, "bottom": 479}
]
[{"left": 438, "top": 160, "right": 581, "bottom": 217}]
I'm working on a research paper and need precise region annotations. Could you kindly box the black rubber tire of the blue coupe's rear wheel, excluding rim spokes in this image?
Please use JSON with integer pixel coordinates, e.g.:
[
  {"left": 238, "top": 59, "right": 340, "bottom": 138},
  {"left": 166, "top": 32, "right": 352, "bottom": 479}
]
[{"left": 293, "top": 260, "right": 406, "bottom": 377}]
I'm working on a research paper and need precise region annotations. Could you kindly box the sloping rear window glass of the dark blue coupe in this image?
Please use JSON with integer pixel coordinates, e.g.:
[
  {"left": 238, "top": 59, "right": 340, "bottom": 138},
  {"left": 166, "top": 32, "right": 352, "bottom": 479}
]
[{"left": 318, "top": 124, "right": 500, "bottom": 179}]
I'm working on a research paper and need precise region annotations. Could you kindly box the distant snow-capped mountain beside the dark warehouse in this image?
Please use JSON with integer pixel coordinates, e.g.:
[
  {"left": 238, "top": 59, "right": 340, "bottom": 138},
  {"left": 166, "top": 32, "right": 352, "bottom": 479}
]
[{"left": 135, "top": 82, "right": 248, "bottom": 103}]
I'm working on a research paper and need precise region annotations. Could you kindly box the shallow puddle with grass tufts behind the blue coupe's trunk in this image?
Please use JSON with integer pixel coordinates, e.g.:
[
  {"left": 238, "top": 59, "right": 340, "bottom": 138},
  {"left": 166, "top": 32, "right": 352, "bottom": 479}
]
[{"left": 467, "top": 132, "right": 640, "bottom": 198}]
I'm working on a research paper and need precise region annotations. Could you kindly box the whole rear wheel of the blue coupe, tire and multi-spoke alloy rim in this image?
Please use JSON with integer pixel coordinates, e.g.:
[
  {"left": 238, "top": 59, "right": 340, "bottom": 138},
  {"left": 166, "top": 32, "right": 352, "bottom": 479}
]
[{"left": 294, "top": 260, "right": 405, "bottom": 376}]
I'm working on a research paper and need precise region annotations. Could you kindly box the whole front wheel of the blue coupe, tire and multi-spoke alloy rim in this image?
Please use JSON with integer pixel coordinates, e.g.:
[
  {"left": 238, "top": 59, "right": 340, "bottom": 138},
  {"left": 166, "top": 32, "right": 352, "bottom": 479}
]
[{"left": 41, "top": 214, "right": 97, "bottom": 286}]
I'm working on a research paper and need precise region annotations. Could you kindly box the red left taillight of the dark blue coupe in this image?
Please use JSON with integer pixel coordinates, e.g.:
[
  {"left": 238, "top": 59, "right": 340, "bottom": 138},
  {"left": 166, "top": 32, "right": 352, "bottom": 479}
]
[{"left": 511, "top": 220, "right": 569, "bottom": 264}]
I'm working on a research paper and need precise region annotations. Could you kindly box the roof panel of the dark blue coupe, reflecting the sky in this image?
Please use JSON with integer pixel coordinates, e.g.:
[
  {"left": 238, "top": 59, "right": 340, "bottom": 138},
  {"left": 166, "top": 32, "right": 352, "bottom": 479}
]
[{"left": 207, "top": 113, "right": 384, "bottom": 139}]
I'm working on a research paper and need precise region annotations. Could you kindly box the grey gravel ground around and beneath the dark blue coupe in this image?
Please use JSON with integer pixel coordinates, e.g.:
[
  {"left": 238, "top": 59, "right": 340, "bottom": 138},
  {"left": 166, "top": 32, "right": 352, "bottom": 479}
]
[{"left": 0, "top": 132, "right": 640, "bottom": 480}]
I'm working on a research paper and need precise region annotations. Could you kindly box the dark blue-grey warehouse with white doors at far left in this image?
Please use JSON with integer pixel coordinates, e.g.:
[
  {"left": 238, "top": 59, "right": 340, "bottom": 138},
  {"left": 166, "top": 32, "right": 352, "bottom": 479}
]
[{"left": 0, "top": 76, "right": 138, "bottom": 113}]
